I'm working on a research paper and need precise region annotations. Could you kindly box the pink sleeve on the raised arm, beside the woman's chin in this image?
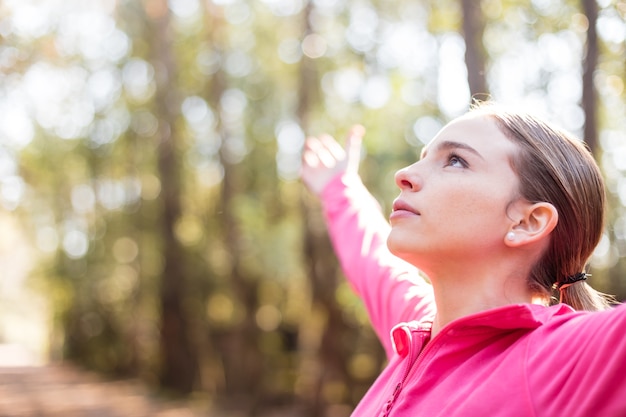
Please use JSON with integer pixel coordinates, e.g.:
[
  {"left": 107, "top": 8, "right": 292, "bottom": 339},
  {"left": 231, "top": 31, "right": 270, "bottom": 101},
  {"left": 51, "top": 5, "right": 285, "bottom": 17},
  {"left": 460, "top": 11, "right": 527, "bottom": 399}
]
[{"left": 321, "top": 174, "right": 435, "bottom": 357}]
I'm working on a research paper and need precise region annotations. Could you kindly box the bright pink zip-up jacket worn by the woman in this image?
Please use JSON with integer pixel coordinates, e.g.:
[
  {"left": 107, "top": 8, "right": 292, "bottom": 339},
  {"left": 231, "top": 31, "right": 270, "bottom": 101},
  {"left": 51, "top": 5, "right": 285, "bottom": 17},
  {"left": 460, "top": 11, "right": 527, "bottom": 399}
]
[{"left": 322, "top": 175, "right": 626, "bottom": 417}]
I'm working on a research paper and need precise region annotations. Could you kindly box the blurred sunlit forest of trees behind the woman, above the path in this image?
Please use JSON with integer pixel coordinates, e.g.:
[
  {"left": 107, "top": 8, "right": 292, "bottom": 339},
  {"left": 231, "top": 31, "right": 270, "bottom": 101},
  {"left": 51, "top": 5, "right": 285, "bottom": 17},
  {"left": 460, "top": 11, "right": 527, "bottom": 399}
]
[{"left": 0, "top": 0, "right": 626, "bottom": 417}]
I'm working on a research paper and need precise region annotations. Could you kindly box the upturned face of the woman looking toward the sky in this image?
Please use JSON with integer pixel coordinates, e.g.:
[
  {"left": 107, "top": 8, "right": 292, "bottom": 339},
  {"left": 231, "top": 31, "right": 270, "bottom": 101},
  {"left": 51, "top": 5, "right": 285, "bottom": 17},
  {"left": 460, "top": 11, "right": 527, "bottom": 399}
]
[{"left": 387, "top": 114, "right": 519, "bottom": 274}]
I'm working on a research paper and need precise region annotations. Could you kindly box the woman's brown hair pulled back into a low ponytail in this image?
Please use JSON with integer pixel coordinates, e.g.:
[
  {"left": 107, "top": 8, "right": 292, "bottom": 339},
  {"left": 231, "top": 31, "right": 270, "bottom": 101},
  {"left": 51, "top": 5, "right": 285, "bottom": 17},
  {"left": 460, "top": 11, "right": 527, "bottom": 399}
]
[{"left": 472, "top": 102, "right": 612, "bottom": 311}]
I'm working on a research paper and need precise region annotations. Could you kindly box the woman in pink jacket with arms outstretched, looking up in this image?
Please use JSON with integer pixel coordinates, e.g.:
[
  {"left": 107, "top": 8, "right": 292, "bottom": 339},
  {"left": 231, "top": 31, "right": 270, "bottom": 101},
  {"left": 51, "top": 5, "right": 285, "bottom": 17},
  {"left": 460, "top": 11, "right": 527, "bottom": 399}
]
[{"left": 302, "top": 101, "right": 626, "bottom": 417}]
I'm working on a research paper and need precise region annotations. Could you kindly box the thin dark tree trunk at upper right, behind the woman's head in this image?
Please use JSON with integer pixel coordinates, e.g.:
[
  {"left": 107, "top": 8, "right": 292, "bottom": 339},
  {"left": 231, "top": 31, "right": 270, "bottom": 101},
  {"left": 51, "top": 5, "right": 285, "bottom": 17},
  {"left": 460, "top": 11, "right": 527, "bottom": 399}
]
[{"left": 582, "top": 0, "right": 598, "bottom": 158}]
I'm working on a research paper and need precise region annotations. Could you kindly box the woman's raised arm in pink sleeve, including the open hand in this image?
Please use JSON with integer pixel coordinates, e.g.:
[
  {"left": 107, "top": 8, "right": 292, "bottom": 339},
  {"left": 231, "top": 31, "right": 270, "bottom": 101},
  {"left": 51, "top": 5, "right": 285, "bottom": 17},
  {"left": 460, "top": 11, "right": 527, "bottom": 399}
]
[{"left": 301, "top": 126, "right": 434, "bottom": 355}]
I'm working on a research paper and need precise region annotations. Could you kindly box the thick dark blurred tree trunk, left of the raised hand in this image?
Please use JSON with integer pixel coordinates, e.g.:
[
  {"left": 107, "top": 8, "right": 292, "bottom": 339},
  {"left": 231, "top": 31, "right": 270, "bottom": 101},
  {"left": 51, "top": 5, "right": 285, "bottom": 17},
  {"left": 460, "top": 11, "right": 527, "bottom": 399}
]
[{"left": 150, "top": 0, "right": 198, "bottom": 394}]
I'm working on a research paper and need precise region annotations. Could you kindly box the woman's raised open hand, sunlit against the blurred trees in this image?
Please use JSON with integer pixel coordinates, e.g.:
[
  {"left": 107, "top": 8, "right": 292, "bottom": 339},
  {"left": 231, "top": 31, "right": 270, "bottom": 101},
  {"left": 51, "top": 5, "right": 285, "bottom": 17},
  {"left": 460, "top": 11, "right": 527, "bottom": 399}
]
[{"left": 300, "top": 125, "right": 365, "bottom": 195}]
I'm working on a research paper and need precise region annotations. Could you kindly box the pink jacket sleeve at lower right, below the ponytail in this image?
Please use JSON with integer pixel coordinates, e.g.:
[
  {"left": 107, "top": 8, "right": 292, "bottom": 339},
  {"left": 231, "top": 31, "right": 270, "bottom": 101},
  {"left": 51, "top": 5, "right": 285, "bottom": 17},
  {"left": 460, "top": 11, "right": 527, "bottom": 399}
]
[{"left": 528, "top": 305, "right": 626, "bottom": 417}]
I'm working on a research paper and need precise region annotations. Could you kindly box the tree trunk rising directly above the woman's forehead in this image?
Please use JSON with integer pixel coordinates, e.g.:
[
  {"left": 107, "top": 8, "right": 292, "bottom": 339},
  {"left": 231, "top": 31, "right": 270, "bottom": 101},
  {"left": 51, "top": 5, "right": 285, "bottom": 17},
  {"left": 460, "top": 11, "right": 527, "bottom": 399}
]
[{"left": 461, "top": 0, "right": 489, "bottom": 98}]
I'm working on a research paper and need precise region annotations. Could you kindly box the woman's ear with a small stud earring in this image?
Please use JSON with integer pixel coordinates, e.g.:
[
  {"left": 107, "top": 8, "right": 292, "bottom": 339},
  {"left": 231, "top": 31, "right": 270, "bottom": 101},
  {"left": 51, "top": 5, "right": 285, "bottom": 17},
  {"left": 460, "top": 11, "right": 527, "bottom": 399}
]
[{"left": 504, "top": 202, "right": 559, "bottom": 247}]
